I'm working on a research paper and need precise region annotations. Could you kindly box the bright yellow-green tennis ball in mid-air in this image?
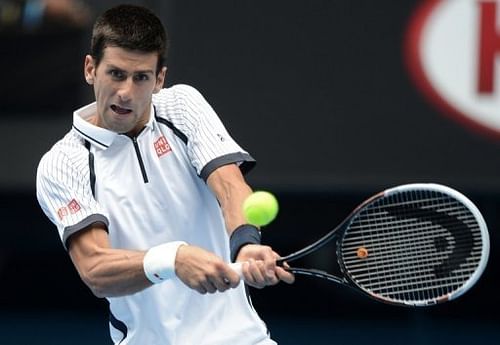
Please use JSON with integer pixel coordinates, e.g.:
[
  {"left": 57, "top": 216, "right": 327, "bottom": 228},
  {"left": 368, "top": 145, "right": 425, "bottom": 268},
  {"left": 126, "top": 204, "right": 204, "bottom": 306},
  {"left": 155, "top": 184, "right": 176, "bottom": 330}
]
[{"left": 243, "top": 191, "right": 279, "bottom": 226}]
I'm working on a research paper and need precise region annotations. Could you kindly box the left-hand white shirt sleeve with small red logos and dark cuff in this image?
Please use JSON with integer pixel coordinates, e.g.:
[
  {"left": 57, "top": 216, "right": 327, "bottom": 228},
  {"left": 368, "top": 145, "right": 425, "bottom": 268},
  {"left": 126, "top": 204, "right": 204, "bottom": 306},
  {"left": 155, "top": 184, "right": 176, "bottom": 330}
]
[{"left": 36, "top": 144, "right": 109, "bottom": 249}]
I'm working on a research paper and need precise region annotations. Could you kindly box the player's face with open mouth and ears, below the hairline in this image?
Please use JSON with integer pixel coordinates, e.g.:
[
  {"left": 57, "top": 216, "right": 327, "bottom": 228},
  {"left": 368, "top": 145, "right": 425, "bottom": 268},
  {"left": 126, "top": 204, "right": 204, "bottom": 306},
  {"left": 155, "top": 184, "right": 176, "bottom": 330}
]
[{"left": 85, "top": 47, "right": 166, "bottom": 135}]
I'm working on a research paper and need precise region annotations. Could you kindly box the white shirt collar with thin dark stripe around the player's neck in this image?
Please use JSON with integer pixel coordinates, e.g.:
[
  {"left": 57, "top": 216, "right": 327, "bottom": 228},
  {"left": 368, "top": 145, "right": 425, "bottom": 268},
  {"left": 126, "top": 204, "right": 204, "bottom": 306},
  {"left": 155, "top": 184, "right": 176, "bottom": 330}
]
[{"left": 73, "top": 102, "right": 155, "bottom": 149}]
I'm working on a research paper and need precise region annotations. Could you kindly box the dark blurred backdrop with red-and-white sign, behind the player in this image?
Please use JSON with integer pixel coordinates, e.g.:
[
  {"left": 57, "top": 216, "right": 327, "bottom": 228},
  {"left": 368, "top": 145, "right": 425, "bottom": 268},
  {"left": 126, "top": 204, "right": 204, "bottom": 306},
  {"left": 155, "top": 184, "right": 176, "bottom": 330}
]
[{"left": 0, "top": 0, "right": 500, "bottom": 345}]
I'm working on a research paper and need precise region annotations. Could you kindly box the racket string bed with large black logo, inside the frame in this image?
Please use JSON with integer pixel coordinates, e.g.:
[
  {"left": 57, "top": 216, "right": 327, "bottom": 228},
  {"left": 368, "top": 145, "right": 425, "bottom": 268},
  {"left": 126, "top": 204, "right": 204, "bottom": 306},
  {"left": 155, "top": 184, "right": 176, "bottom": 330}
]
[{"left": 338, "top": 191, "right": 481, "bottom": 301}]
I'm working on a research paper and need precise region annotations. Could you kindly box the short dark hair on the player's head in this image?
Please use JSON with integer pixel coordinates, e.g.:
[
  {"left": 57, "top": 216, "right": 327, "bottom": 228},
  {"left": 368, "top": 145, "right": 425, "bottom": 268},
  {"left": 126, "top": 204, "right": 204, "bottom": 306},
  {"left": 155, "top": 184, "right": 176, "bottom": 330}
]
[{"left": 90, "top": 5, "right": 168, "bottom": 73}]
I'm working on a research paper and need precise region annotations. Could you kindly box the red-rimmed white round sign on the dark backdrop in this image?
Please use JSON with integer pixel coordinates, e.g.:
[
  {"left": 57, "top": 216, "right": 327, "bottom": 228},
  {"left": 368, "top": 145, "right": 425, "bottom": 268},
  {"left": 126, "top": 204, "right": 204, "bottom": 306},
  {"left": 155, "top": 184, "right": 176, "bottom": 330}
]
[{"left": 405, "top": 0, "right": 500, "bottom": 138}]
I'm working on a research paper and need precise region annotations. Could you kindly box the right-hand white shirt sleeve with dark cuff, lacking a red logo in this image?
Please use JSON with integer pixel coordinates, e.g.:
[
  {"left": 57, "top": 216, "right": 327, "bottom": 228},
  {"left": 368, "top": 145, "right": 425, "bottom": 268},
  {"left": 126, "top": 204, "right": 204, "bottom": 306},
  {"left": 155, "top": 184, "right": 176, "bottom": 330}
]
[{"left": 168, "top": 85, "right": 255, "bottom": 180}]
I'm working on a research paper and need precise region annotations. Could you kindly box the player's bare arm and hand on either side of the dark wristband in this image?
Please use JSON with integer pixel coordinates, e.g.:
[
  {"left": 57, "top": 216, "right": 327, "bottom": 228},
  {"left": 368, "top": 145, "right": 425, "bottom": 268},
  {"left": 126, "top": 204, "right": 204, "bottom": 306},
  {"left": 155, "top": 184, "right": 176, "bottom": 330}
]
[{"left": 207, "top": 164, "right": 295, "bottom": 288}]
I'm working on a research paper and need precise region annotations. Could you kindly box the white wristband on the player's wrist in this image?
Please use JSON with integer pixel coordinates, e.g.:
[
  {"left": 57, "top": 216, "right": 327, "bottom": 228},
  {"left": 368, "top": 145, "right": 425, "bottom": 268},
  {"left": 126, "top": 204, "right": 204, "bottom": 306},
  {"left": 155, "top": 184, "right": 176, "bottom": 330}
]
[{"left": 142, "top": 241, "right": 187, "bottom": 284}]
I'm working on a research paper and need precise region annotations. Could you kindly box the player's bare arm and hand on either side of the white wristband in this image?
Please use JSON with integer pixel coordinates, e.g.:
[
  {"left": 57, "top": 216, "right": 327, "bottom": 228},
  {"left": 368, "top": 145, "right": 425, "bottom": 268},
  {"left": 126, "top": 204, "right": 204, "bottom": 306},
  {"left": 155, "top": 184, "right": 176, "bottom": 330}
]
[{"left": 68, "top": 223, "right": 239, "bottom": 297}]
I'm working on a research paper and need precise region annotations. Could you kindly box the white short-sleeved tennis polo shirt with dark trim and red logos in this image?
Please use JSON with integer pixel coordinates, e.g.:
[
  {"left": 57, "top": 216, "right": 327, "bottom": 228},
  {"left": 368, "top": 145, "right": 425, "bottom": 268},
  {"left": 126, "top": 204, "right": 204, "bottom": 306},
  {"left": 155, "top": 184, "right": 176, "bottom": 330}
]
[{"left": 37, "top": 85, "right": 276, "bottom": 345}]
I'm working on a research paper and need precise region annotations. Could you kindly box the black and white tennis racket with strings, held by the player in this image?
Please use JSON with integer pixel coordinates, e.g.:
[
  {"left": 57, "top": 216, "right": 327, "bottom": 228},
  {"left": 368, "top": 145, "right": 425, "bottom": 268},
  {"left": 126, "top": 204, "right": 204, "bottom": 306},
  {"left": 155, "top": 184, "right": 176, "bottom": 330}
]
[{"left": 233, "top": 184, "right": 489, "bottom": 307}]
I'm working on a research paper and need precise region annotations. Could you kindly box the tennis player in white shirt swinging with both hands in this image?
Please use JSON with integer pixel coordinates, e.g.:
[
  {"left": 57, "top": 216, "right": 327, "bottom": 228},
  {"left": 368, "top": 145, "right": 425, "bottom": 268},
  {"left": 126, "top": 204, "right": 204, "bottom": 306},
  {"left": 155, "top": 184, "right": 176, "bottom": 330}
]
[{"left": 37, "top": 5, "right": 294, "bottom": 345}]
